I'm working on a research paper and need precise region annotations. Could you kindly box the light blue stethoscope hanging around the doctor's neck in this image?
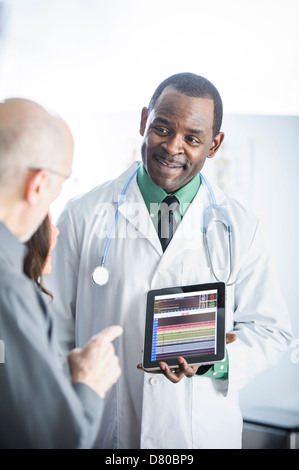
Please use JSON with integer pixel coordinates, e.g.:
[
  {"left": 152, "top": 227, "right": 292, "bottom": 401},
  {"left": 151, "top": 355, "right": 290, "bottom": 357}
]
[{"left": 92, "top": 163, "right": 234, "bottom": 286}]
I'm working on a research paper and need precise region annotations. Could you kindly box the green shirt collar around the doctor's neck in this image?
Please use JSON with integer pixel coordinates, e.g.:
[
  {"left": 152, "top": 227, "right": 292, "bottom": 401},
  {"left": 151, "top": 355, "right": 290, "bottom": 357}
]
[{"left": 137, "top": 165, "right": 201, "bottom": 216}]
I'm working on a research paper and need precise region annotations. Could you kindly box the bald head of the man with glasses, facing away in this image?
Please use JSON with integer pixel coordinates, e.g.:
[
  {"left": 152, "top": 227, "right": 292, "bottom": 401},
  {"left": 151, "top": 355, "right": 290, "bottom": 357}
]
[{"left": 0, "top": 98, "right": 73, "bottom": 241}]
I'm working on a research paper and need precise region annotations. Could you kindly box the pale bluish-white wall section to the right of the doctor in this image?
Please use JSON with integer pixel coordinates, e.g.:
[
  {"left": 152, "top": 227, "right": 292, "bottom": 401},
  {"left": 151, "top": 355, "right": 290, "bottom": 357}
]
[{"left": 217, "top": 115, "right": 299, "bottom": 414}]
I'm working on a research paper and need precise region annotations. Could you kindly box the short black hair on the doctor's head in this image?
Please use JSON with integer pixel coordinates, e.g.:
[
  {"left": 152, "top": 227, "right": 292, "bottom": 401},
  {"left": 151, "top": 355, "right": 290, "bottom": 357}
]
[{"left": 148, "top": 72, "right": 223, "bottom": 137}]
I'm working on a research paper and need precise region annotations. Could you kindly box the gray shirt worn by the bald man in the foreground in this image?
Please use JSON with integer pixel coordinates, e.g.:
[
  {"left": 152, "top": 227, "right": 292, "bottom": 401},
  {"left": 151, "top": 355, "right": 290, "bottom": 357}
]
[{"left": 0, "top": 222, "right": 103, "bottom": 449}]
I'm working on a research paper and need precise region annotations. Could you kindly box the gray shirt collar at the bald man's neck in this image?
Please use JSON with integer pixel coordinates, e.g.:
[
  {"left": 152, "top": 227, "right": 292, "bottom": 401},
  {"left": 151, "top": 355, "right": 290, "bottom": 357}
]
[{"left": 0, "top": 221, "right": 27, "bottom": 271}]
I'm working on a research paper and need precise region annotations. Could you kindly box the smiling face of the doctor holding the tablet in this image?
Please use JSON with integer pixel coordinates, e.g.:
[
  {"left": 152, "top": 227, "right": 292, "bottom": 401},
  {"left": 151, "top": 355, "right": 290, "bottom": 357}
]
[{"left": 140, "top": 86, "right": 224, "bottom": 193}]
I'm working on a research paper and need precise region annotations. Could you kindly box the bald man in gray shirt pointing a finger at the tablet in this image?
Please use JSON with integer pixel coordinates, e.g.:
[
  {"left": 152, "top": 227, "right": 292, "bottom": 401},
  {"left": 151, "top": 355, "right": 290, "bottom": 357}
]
[{"left": 0, "top": 99, "right": 122, "bottom": 448}]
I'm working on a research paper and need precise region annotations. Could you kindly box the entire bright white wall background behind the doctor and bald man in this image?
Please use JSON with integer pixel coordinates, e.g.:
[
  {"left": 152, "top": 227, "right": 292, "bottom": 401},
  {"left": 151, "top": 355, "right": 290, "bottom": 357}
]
[{"left": 0, "top": 0, "right": 299, "bottom": 418}]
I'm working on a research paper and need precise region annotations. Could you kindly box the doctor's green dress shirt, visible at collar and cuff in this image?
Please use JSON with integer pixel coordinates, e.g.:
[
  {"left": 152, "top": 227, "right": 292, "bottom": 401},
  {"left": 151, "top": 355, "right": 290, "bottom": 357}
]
[{"left": 137, "top": 165, "right": 228, "bottom": 380}]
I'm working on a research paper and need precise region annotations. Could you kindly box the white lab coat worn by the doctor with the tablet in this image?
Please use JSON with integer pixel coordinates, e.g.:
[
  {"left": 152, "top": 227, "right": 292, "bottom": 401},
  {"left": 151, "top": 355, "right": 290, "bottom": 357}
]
[{"left": 47, "top": 163, "right": 291, "bottom": 449}]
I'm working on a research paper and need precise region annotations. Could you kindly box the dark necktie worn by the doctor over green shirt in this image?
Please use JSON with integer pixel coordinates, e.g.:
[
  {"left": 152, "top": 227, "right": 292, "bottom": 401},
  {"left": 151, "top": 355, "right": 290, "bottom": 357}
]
[{"left": 158, "top": 196, "right": 179, "bottom": 251}]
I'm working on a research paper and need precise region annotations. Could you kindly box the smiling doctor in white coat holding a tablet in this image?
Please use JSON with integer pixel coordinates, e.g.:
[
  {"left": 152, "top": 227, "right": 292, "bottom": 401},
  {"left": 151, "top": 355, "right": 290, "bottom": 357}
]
[{"left": 48, "top": 74, "right": 291, "bottom": 449}]
